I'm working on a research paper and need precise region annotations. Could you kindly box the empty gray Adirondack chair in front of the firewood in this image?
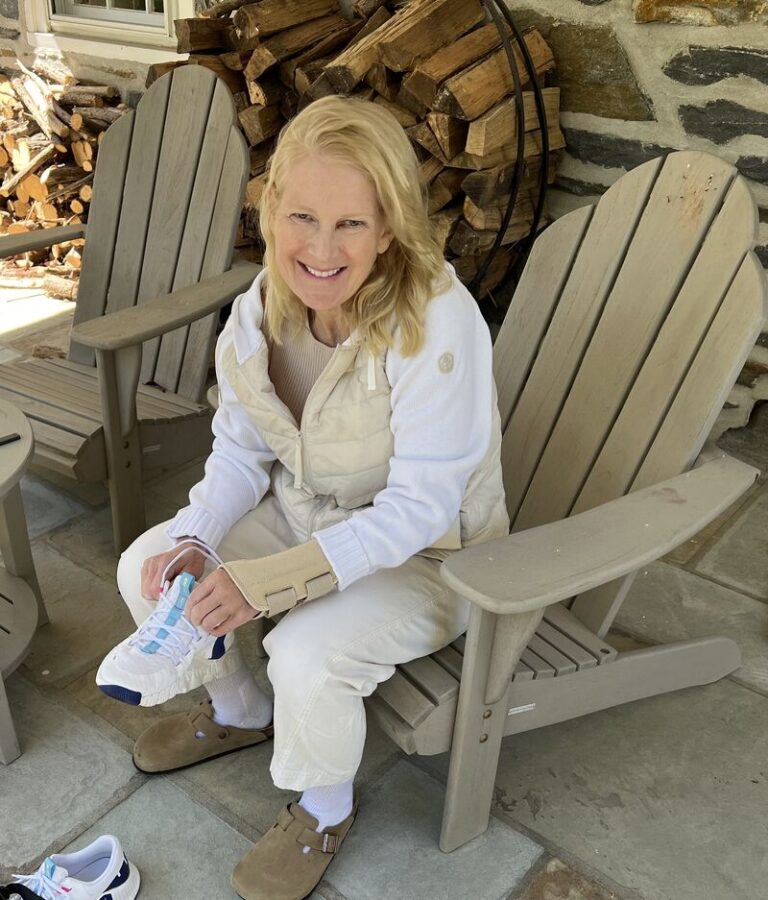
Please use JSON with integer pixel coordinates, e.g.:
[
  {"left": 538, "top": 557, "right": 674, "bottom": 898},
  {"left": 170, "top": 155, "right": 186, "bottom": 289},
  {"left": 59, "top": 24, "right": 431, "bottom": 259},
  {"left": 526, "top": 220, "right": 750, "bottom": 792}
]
[{"left": 0, "top": 66, "right": 258, "bottom": 552}]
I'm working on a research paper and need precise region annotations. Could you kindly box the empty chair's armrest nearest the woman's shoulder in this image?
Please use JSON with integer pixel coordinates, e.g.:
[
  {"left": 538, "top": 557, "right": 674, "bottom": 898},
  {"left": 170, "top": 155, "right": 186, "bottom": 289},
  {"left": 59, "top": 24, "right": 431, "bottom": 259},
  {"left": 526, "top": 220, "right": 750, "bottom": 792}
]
[{"left": 72, "top": 263, "right": 261, "bottom": 351}]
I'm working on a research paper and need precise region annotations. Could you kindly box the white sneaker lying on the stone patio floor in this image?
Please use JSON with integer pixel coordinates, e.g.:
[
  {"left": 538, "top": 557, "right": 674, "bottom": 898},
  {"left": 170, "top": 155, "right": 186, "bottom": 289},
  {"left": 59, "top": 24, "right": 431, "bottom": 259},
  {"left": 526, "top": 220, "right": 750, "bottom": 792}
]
[{"left": 0, "top": 834, "right": 140, "bottom": 900}]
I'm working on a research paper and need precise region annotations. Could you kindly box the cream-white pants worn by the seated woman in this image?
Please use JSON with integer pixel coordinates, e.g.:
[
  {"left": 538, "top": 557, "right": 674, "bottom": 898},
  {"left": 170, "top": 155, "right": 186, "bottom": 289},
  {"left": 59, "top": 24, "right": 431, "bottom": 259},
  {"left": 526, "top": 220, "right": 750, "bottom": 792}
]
[{"left": 117, "top": 494, "right": 469, "bottom": 791}]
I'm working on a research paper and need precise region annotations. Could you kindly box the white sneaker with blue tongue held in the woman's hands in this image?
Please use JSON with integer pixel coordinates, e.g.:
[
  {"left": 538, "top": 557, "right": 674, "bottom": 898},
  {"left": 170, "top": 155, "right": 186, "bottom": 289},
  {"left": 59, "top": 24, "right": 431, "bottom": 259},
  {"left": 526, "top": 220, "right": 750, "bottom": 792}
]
[{"left": 96, "top": 572, "right": 237, "bottom": 706}]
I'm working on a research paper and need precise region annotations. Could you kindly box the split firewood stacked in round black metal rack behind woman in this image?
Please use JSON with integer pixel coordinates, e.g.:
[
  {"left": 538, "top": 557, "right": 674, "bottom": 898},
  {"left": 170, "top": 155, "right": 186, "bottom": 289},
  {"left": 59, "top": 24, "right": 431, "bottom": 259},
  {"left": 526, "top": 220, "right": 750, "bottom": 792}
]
[{"left": 159, "top": 0, "right": 564, "bottom": 293}]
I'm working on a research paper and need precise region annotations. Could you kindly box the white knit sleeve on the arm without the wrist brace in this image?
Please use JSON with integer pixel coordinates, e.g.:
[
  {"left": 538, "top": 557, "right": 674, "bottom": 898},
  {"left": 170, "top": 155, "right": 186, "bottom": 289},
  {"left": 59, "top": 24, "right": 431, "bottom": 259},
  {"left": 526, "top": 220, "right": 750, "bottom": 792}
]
[{"left": 166, "top": 328, "right": 275, "bottom": 549}]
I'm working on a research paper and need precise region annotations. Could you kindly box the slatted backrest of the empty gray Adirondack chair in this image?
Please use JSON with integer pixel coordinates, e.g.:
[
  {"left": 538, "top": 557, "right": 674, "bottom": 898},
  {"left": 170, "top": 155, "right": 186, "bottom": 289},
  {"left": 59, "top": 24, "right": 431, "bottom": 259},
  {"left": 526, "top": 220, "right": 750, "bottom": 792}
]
[{"left": 70, "top": 66, "right": 248, "bottom": 400}]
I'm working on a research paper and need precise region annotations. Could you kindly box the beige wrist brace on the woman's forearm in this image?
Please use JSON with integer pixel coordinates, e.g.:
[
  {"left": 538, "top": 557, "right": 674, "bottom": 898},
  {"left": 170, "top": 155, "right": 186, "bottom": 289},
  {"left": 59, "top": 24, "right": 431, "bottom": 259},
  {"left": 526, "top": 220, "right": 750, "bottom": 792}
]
[{"left": 221, "top": 540, "right": 337, "bottom": 618}]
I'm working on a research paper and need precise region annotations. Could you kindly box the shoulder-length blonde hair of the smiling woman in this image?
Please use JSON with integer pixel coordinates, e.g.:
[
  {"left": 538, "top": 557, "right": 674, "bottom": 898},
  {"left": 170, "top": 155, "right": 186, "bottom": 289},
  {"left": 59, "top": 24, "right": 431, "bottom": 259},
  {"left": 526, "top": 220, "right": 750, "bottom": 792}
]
[{"left": 259, "top": 96, "right": 450, "bottom": 356}]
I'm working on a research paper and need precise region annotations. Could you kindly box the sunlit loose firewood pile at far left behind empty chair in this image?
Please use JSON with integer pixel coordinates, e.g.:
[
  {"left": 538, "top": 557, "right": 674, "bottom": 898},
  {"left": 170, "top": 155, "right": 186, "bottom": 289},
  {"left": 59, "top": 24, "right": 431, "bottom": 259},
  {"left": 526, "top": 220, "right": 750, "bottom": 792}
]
[{"left": 0, "top": 57, "right": 127, "bottom": 299}]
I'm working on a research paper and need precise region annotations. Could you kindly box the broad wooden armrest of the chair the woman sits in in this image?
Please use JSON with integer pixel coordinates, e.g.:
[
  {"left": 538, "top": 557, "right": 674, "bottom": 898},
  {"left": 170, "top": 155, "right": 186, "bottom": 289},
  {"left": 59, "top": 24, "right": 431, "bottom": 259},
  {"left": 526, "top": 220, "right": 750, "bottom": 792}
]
[{"left": 440, "top": 452, "right": 760, "bottom": 614}]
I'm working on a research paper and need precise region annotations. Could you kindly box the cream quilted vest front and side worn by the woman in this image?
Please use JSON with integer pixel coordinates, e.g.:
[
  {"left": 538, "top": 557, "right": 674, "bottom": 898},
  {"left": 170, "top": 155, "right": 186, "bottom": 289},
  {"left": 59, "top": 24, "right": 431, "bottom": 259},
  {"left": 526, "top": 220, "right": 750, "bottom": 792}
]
[{"left": 219, "top": 320, "right": 509, "bottom": 558}]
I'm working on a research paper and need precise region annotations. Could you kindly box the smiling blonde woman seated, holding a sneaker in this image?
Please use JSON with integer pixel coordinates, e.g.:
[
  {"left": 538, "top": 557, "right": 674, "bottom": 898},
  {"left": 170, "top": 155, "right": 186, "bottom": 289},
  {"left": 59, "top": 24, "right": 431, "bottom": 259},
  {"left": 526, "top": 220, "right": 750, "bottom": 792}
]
[{"left": 100, "top": 97, "right": 508, "bottom": 900}]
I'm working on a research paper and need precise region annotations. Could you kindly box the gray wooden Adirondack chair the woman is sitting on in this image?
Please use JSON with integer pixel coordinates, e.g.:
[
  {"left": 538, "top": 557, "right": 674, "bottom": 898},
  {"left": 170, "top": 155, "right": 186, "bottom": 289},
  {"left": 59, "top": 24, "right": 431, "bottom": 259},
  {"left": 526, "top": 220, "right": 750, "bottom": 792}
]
[{"left": 368, "top": 152, "right": 766, "bottom": 851}]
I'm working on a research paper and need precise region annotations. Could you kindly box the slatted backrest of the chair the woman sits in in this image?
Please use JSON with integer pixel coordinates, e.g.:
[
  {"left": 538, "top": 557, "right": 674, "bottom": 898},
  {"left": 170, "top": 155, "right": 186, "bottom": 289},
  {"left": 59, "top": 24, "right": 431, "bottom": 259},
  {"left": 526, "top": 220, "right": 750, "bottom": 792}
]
[{"left": 495, "top": 152, "right": 766, "bottom": 530}]
